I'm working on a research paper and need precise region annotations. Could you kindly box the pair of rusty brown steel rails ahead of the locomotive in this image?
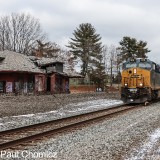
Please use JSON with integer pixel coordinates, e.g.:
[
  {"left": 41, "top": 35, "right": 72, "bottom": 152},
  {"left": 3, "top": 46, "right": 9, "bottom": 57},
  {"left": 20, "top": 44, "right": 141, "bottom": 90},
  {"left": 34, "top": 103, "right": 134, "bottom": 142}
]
[{"left": 0, "top": 104, "right": 145, "bottom": 150}]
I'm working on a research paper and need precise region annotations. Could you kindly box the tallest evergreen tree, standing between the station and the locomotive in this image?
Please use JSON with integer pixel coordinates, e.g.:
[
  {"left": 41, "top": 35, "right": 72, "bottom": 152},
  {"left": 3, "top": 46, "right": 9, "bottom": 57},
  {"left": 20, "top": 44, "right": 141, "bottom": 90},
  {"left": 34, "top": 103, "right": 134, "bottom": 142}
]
[{"left": 67, "top": 23, "right": 103, "bottom": 76}]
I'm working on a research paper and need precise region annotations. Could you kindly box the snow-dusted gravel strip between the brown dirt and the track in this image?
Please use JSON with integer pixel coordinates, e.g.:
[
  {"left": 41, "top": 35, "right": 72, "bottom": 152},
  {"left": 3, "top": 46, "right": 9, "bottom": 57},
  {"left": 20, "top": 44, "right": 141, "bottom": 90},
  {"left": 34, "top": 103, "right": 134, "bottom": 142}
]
[{"left": 0, "top": 99, "right": 123, "bottom": 131}]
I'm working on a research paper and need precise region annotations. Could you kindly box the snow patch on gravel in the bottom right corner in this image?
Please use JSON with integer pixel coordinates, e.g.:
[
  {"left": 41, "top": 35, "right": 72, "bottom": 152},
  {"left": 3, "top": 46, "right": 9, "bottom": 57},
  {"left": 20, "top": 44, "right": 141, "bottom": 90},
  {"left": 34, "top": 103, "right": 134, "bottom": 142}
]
[{"left": 127, "top": 128, "right": 160, "bottom": 160}]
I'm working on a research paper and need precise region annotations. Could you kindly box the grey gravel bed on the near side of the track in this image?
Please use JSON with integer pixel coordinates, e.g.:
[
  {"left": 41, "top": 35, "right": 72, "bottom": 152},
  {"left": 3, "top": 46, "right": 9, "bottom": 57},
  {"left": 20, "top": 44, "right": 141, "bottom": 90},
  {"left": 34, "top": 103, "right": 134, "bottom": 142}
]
[{"left": 9, "top": 100, "right": 160, "bottom": 160}]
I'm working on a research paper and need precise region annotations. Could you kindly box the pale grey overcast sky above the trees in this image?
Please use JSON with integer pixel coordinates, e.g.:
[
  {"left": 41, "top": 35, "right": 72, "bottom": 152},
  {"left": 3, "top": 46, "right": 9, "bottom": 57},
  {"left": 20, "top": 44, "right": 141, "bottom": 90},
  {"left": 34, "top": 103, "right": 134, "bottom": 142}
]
[{"left": 0, "top": 0, "right": 160, "bottom": 63}]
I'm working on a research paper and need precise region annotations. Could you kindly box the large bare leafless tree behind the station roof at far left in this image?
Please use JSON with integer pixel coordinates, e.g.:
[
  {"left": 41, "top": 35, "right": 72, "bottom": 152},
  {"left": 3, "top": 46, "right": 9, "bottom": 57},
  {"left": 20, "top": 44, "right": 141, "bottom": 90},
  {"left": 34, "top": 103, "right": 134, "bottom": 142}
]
[{"left": 0, "top": 13, "right": 46, "bottom": 55}]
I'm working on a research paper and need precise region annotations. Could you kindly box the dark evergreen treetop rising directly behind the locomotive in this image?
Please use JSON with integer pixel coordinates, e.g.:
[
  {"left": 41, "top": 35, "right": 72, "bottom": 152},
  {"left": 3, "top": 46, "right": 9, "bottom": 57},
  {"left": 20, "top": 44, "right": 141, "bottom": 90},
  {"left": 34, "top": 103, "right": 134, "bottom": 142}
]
[{"left": 118, "top": 37, "right": 150, "bottom": 61}]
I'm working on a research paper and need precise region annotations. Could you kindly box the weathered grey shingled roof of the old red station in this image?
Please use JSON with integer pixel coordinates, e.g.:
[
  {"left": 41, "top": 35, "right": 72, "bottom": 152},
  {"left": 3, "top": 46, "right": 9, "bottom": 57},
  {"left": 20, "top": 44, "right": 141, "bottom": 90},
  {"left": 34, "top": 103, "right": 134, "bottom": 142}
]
[{"left": 0, "top": 50, "right": 83, "bottom": 78}]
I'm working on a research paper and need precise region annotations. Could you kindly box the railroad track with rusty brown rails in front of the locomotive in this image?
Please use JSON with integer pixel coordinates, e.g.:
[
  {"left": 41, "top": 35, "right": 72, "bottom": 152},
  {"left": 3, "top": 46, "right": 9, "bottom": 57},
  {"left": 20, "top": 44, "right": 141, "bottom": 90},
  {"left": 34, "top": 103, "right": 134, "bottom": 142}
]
[{"left": 0, "top": 104, "right": 144, "bottom": 150}]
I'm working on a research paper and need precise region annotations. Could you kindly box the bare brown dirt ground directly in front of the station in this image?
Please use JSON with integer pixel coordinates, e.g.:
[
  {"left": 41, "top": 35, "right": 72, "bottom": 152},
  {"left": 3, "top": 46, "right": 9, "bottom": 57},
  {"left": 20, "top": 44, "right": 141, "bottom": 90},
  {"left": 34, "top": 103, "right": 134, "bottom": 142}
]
[{"left": 0, "top": 92, "right": 119, "bottom": 118}]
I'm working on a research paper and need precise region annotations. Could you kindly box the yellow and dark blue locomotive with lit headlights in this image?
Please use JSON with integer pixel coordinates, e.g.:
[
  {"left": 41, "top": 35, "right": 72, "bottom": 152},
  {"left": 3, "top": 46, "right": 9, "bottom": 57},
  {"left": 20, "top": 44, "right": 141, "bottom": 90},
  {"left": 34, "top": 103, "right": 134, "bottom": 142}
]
[{"left": 121, "top": 58, "right": 160, "bottom": 103}]
